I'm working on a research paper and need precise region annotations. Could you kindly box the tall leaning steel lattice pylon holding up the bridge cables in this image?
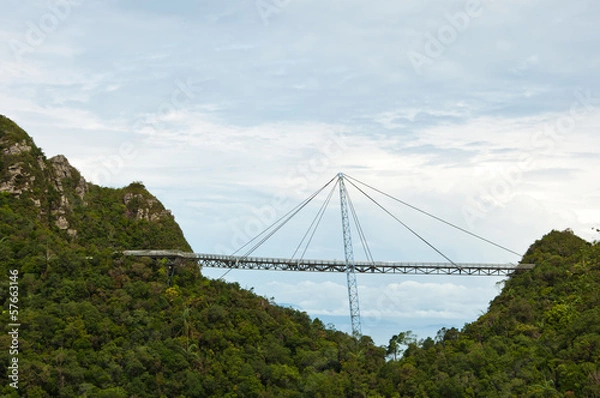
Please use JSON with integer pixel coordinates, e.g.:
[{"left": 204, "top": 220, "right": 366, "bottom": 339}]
[{"left": 338, "top": 173, "right": 362, "bottom": 339}]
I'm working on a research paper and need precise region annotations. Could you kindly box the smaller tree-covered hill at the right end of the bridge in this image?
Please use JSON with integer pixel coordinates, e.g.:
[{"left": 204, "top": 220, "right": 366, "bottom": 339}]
[{"left": 380, "top": 231, "right": 600, "bottom": 397}]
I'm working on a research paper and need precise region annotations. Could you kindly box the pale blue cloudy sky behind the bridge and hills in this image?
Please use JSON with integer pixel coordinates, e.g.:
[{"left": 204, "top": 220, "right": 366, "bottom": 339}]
[{"left": 0, "top": 0, "right": 600, "bottom": 345}]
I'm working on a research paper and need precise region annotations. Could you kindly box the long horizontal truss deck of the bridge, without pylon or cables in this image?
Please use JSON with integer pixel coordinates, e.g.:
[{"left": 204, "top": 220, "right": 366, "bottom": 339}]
[{"left": 123, "top": 250, "right": 534, "bottom": 276}]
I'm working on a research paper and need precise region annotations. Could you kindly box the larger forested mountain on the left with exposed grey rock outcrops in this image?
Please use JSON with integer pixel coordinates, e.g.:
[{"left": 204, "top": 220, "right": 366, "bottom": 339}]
[{"left": 0, "top": 117, "right": 385, "bottom": 397}]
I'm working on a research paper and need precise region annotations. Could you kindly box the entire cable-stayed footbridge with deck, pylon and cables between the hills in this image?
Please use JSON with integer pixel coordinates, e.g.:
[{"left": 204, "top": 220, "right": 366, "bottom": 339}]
[{"left": 124, "top": 173, "right": 534, "bottom": 338}]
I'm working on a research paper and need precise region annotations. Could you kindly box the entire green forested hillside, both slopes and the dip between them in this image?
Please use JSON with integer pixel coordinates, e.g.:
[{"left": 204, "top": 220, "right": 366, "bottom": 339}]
[{"left": 0, "top": 116, "right": 600, "bottom": 397}]
